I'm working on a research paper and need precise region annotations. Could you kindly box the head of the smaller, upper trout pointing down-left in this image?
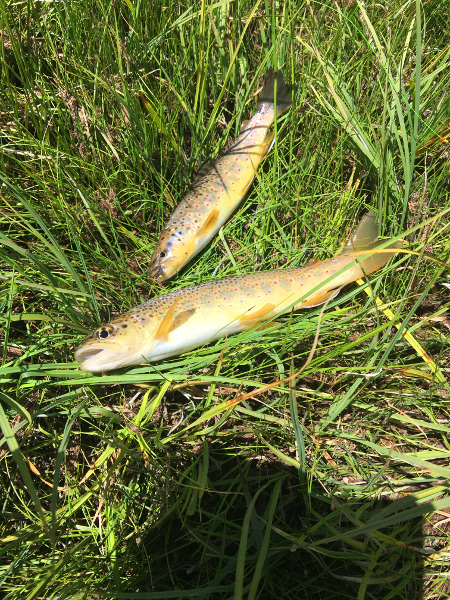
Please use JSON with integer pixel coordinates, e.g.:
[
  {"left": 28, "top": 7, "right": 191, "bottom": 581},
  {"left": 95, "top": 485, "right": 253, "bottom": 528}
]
[{"left": 149, "top": 226, "right": 196, "bottom": 281}]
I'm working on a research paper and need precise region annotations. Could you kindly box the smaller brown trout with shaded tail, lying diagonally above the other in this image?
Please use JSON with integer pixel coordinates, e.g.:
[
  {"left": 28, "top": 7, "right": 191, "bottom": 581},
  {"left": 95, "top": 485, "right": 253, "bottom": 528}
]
[{"left": 150, "top": 70, "right": 293, "bottom": 281}]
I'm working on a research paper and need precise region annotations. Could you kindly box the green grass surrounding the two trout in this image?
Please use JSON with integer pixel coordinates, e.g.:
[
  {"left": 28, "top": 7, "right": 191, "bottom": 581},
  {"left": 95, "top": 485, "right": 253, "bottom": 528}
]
[{"left": 0, "top": 0, "right": 450, "bottom": 600}]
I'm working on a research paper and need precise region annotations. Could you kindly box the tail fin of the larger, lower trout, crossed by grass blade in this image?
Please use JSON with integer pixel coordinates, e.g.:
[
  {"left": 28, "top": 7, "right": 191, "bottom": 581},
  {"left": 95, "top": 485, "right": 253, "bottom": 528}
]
[{"left": 339, "top": 211, "right": 402, "bottom": 274}]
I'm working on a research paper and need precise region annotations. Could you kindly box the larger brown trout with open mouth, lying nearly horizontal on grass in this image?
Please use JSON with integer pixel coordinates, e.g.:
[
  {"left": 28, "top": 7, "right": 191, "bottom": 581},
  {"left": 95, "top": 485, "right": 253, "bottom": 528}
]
[{"left": 75, "top": 213, "right": 398, "bottom": 371}]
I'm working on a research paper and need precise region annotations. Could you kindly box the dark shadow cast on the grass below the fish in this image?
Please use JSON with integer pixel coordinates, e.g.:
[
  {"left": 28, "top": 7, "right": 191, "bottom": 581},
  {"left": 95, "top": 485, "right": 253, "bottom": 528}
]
[{"left": 114, "top": 446, "right": 432, "bottom": 600}]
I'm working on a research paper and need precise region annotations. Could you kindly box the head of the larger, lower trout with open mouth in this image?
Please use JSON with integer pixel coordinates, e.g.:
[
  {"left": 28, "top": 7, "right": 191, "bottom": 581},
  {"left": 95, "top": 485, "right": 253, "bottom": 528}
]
[{"left": 75, "top": 311, "right": 158, "bottom": 372}]
